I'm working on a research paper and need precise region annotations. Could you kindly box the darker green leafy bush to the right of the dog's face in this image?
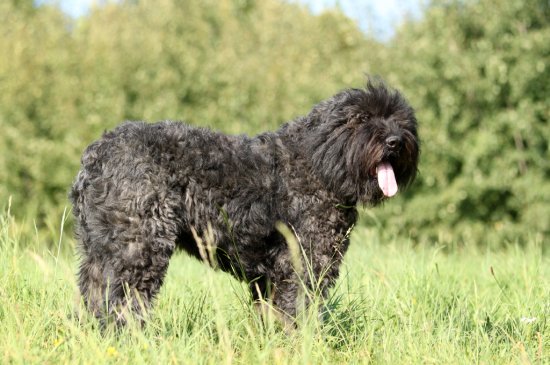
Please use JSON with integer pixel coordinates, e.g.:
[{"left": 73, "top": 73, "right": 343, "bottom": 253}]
[{"left": 364, "top": 0, "right": 550, "bottom": 244}]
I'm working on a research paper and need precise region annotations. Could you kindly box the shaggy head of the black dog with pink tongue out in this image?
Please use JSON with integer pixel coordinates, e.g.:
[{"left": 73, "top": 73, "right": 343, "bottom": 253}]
[{"left": 308, "top": 80, "right": 420, "bottom": 205}]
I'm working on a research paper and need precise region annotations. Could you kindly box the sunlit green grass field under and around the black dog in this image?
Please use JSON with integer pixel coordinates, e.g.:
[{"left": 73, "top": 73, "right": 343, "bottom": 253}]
[{"left": 0, "top": 210, "right": 550, "bottom": 364}]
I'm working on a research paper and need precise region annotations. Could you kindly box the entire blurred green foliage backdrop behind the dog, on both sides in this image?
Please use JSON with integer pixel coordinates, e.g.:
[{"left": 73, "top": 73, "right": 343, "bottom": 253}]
[{"left": 0, "top": 0, "right": 550, "bottom": 244}]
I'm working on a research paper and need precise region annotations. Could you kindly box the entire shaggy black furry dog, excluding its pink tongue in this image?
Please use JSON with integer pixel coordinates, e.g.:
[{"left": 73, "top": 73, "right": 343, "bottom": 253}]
[{"left": 70, "top": 81, "right": 419, "bottom": 323}]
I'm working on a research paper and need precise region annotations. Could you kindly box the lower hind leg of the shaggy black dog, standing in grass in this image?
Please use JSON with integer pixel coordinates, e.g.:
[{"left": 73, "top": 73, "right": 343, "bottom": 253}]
[{"left": 75, "top": 206, "right": 176, "bottom": 325}]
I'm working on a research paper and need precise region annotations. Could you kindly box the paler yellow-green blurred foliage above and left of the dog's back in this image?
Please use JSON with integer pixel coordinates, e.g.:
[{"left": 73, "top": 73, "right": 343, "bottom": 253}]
[{"left": 0, "top": 0, "right": 378, "bottom": 226}]
